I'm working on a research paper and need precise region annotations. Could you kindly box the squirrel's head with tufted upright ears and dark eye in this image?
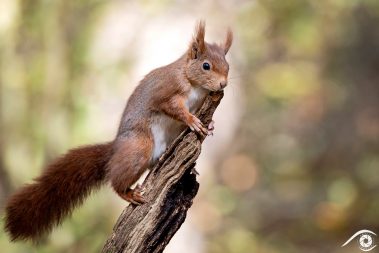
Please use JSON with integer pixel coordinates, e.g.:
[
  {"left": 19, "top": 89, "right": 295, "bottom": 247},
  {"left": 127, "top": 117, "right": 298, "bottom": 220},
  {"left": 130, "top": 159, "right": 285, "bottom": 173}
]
[{"left": 186, "top": 20, "right": 233, "bottom": 91}]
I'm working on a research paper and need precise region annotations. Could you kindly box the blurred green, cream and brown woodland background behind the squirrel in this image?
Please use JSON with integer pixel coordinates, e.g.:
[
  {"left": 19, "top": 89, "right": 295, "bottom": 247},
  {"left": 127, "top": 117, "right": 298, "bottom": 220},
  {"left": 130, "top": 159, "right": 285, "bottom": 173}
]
[{"left": 0, "top": 0, "right": 379, "bottom": 253}]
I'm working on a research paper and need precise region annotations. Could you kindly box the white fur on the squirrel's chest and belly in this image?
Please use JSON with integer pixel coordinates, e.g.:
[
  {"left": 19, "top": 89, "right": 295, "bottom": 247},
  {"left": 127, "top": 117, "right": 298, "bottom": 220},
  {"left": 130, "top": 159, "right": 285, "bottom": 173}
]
[{"left": 151, "top": 88, "right": 207, "bottom": 163}]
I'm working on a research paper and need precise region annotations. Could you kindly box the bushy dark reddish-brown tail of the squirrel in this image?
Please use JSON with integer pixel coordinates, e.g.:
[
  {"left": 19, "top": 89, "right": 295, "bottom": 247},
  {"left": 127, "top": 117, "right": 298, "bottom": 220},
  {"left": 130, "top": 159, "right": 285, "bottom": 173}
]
[{"left": 5, "top": 143, "right": 112, "bottom": 241}]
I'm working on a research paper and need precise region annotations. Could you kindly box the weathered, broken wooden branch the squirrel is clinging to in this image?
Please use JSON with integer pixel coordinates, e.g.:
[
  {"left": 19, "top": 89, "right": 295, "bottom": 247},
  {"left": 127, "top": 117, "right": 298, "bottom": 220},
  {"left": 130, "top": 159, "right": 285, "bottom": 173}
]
[{"left": 102, "top": 91, "right": 224, "bottom": 253}]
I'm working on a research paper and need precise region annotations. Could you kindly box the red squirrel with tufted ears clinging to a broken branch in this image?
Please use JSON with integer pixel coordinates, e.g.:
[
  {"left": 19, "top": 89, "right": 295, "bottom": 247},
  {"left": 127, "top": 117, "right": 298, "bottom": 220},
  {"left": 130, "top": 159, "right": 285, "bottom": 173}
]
[{"left": 5, "top": 21, "right": 233, "bottom": 241}]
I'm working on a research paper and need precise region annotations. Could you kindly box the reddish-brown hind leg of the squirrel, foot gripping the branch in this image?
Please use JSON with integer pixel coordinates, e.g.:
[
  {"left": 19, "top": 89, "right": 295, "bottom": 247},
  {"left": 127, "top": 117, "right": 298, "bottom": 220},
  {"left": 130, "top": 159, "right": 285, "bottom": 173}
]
[{"left": 108, "top": 135, "right": 153, "bottom": 205}]
